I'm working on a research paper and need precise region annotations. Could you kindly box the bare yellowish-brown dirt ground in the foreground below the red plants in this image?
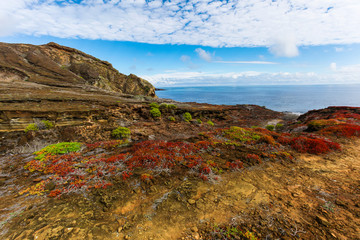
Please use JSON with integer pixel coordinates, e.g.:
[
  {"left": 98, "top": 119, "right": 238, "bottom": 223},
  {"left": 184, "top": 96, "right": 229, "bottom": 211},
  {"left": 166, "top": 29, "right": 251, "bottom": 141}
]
[{"left": 1, "top": 140, "right": 360, "bottom": 240}]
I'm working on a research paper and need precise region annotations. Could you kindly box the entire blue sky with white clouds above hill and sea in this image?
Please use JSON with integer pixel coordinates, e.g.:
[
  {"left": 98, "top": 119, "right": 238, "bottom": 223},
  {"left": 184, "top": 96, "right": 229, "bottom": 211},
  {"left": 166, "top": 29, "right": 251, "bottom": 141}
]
[{"left": 0, "top": 0, "right": 360, "bottom": 87}]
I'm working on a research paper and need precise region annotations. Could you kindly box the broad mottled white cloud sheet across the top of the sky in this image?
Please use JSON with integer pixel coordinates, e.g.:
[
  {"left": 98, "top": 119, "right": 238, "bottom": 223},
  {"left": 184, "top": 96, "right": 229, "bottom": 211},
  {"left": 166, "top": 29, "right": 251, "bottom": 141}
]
[{"left": 0, "top": 0, "right": 360, "bottom": 48}]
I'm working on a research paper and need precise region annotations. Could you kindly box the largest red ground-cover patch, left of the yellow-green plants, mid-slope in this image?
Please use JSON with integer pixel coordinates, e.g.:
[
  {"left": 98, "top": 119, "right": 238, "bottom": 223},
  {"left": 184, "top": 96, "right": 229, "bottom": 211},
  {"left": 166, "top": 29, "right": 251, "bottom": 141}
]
[{"left": 22, "top": 141, "right": 216, "bottom": 197}]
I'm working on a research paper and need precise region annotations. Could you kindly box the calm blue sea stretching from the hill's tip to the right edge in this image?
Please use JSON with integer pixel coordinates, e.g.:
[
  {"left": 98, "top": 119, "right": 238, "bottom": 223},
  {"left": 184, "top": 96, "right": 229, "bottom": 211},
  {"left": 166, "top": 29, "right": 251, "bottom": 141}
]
[{"left": 156, "top": 84, "right": 360, "bottom": 113}]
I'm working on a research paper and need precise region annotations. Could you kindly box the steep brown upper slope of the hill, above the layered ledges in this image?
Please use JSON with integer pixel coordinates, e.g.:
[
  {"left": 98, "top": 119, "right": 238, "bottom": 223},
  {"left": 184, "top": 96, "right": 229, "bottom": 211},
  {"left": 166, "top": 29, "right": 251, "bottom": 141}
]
[{"left": 0, "top": 42, "right": 156, "bottom": 97}]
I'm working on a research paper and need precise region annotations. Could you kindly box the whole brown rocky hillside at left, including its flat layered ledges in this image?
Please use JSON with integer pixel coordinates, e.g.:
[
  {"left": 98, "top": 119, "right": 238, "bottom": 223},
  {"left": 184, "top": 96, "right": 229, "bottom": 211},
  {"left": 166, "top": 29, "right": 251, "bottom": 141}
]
[{"left": 0, "top": 40, "right": 160, "bottom": 131}]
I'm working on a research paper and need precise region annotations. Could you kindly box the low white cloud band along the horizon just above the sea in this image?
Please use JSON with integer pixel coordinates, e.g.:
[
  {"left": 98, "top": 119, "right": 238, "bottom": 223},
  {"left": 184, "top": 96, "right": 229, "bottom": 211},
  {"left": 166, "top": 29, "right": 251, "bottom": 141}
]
[{"left": 141, "top": 63, "right": 360, "bottom": 87}]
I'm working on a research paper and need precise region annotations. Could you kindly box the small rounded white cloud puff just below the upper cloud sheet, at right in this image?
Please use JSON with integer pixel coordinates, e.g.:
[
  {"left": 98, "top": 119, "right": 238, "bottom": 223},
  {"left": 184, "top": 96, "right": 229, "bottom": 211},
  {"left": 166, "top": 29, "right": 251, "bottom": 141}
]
[{"left": 269, "top": 36, "right": 299, "bottom": 57}]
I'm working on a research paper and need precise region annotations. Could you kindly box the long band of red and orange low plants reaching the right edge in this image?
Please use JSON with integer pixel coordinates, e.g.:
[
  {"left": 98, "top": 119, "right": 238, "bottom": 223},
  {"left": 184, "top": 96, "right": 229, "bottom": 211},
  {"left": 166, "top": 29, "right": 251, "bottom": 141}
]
[{"left": 23, "top": 107, "right": 360, "bottom": 197}]
